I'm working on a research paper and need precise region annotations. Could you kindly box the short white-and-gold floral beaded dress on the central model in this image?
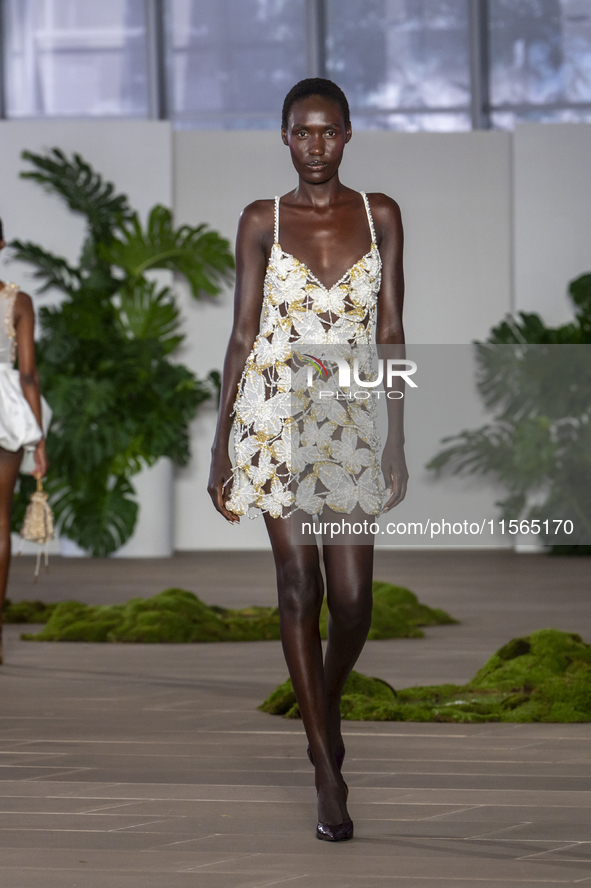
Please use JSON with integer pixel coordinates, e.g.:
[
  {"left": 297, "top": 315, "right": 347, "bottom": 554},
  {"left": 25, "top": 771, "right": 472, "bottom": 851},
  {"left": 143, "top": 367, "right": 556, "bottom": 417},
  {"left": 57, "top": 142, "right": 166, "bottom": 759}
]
[{"left": 226, "top": 192, "right": 385, "bottom": 518}]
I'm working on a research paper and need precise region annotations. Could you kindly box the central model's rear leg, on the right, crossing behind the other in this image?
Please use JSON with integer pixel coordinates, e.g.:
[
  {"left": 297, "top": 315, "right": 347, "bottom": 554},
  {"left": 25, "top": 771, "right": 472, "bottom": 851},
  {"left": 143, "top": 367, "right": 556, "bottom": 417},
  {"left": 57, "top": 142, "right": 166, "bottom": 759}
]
[{"left": 322, "top": 544, "right": 373, "bottom": 754}]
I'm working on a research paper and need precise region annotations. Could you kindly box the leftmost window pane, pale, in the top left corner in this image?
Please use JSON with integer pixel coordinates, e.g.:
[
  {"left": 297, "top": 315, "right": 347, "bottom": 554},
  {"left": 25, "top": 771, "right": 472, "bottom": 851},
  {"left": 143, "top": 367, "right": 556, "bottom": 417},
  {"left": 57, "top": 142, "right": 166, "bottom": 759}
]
[{"left": 4, "top": 0, "right": 148, "bottom": 117}]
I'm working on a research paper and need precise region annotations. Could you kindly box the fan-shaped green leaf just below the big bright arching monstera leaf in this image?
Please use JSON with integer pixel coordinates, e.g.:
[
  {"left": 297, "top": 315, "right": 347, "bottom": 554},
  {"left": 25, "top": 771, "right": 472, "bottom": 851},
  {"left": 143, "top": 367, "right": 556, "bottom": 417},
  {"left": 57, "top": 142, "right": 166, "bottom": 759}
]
[{"left": 117, "top": 278, "right": 184, "bottom": 355}]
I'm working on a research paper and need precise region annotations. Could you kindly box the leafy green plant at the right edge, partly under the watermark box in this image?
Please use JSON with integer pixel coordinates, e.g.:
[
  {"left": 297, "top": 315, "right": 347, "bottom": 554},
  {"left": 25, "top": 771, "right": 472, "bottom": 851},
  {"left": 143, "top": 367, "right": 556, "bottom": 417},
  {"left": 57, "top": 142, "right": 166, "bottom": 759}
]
[{"left": 428, "top": 274, "right": 591, "bottom": 554}]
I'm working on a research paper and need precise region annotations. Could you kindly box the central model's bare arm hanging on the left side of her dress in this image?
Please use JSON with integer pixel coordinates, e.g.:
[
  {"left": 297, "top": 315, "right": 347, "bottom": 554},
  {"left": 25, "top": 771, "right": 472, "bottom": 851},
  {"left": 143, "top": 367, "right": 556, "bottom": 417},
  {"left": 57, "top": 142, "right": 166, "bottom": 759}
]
[{"left": 207, "top": 201, "right": 273, "bottom": 523}]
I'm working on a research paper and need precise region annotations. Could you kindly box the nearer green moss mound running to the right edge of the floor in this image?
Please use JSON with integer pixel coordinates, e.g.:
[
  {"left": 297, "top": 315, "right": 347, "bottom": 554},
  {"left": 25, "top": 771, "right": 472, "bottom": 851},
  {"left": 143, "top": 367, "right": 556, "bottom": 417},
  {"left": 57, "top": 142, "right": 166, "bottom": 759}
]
[{"left": 260, "top": 629, "right": 591, "bottom": 722}]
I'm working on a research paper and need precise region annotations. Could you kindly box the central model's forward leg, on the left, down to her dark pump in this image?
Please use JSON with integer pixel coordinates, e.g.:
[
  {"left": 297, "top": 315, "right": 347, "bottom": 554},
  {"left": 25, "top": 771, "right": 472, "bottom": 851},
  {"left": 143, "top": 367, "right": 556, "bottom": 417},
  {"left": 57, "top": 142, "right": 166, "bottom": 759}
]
[{"left": 265, "top": 515, "right": 349, "bottom": 825}]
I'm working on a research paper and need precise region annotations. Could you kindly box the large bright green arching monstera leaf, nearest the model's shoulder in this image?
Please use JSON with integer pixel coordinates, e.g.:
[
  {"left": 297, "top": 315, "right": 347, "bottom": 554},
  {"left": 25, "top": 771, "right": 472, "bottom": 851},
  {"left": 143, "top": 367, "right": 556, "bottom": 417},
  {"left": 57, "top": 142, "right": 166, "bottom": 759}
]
[{"left": 101, "top": 204, "right": 234, "bottom": 298}]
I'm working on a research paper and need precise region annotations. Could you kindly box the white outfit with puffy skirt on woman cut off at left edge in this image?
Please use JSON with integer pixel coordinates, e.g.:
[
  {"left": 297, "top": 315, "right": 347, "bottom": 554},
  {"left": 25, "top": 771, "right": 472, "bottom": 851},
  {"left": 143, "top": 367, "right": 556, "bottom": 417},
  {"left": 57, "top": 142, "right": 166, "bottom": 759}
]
[{"left": 0, "top": 283, "right": 51, "bottom": 462}]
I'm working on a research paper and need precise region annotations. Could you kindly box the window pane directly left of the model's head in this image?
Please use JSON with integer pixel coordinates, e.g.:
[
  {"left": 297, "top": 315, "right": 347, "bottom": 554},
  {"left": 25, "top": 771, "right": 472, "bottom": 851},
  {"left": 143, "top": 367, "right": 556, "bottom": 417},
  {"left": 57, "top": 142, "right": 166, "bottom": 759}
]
[{"left": 168, "top": 0, "right": 307, "bottom": 129}]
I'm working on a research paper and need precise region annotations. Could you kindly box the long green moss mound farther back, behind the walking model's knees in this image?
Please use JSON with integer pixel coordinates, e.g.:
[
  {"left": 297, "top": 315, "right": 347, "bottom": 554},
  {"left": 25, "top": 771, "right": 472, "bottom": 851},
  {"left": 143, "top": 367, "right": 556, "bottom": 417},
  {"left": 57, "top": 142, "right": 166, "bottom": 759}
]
[{"left": 11, "top": 582, "right": 457, "bottom": 643}]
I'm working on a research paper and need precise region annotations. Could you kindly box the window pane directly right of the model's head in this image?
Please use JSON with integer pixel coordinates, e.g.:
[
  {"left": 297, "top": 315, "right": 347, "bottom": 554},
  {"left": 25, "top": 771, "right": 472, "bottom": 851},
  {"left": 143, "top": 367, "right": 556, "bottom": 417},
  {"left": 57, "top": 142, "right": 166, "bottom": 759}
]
[{"left": 327, "top": 0, "right": 470, "bottom": 129}]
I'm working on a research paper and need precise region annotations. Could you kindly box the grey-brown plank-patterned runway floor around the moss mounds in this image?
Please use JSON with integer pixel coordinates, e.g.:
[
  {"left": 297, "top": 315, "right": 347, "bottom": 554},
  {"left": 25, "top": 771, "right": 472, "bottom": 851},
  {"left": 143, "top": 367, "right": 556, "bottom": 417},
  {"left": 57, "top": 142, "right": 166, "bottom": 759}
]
[{"left": 0, "top": 551, "right": 591, "bottom": 888}]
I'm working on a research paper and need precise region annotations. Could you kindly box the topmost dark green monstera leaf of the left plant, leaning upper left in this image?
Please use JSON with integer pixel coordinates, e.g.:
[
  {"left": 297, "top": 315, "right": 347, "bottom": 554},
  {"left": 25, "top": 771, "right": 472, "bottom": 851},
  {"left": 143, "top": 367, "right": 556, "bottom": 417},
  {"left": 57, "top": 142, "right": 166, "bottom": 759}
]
[{"left": 20, "top": 148, "right": 132, "bottom": 239}]
